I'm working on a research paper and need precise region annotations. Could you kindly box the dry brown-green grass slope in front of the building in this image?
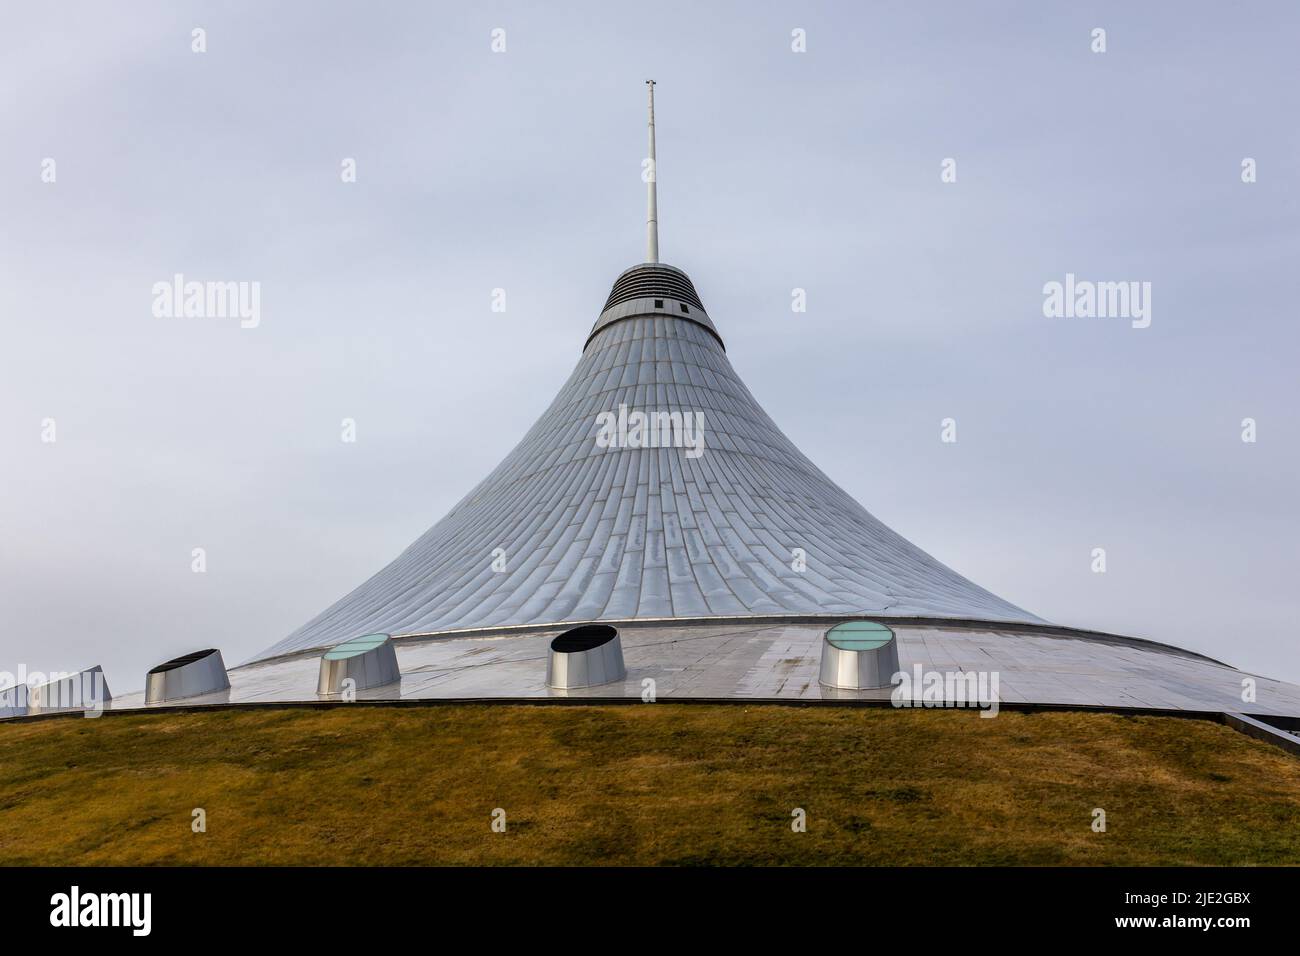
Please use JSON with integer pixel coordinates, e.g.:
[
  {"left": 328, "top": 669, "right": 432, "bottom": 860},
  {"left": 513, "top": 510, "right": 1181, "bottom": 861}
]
[{"left": 0, "top": 704, "right": 1300, "bottom": 865}]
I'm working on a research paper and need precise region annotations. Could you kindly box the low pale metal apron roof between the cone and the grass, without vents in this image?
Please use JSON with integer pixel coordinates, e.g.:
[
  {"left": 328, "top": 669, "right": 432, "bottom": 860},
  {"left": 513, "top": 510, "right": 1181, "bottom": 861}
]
[{"left": 40, "top": 619, "right": 1300, "bottom": 717}]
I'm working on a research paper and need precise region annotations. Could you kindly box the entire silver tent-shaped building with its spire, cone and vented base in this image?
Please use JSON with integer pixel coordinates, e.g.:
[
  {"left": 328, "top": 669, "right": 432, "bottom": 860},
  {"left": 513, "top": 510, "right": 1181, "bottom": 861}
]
[{"left": 0, "top": 95, "right": 1300, "bottom": 719}]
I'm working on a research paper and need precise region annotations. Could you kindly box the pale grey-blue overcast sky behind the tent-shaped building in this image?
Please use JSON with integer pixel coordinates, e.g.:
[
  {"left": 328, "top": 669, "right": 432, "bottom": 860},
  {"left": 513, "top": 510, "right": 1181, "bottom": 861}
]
[{"left": 0, "top": 0, "right": 1300, "bottom": 693}]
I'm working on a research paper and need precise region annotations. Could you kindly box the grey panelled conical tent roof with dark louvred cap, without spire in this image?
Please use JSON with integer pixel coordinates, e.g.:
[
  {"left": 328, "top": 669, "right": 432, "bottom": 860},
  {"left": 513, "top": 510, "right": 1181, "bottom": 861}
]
[{"left": 259, "top": 263, "right": 1043, "bottom": 658}]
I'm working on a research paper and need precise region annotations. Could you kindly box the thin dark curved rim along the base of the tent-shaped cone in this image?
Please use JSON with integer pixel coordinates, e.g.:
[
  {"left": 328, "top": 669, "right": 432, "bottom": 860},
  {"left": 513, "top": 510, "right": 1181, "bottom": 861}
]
[{"left": 230, "top": 611, "right": 1236, "bottom": 670}]
